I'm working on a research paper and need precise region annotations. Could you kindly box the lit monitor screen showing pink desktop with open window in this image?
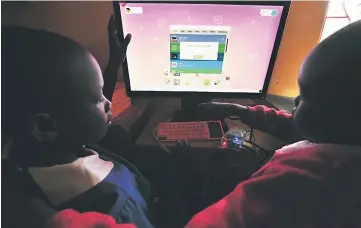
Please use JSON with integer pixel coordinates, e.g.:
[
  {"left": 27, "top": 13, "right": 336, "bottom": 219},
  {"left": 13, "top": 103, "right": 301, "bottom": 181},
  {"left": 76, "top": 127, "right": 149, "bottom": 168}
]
[{"left": 119, "top": 3, "right": 284, "bottom": 94}]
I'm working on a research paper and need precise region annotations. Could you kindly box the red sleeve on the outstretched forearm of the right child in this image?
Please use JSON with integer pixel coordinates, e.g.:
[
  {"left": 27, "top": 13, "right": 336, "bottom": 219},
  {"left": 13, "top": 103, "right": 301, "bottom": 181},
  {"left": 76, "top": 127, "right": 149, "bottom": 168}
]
[{"left": 242, "top": 105, "right": 303, "bottom": 143}]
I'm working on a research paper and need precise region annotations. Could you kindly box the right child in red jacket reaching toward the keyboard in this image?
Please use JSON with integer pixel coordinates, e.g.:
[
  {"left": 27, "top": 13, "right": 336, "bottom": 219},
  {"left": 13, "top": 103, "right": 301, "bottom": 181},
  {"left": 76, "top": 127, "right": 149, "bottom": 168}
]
[{"left": 186, "top": 21, "right": 361, "bottom": 228}]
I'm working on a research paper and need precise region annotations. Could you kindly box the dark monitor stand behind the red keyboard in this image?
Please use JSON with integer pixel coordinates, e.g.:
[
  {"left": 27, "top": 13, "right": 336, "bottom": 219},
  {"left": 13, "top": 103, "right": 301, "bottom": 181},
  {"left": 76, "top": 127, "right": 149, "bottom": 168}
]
[{"left": 172, "top": 96, "right": 212, "bottom": 122}]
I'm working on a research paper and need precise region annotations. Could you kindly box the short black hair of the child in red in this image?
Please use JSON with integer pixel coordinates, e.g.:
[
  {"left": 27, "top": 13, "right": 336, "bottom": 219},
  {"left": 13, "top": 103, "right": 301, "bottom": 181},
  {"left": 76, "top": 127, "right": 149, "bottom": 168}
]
[{"left": 300, "top": 20, "right": 361, "bottom": 105}]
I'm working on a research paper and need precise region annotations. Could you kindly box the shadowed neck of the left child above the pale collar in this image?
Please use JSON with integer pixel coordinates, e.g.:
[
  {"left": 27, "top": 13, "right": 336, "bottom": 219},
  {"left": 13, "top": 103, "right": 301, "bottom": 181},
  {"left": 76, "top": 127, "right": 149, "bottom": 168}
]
[{"left": 11, "top": 139, "right": 86, "bottom": 167}]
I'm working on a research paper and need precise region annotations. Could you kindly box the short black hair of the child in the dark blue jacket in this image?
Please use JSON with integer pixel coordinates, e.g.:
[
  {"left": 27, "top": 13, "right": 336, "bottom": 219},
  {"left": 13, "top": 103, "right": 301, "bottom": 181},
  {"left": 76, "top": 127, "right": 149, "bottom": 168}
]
[{"left": 1, "top": 26, "right": 79, "bottom": 137}]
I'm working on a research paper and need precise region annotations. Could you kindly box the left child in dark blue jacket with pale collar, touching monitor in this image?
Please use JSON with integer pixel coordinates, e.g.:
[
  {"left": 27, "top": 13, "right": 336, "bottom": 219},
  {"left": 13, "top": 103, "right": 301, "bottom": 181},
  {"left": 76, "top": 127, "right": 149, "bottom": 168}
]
[{"left": 1, "top": 17, "right": 153, "bottom": 228}]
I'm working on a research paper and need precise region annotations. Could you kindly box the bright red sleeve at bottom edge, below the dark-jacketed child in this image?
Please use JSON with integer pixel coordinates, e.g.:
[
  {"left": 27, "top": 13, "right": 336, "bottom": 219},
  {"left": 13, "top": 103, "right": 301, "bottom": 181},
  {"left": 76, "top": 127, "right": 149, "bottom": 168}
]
[{"left": 45, "top": 209, "right": 136, "bottom": 228}]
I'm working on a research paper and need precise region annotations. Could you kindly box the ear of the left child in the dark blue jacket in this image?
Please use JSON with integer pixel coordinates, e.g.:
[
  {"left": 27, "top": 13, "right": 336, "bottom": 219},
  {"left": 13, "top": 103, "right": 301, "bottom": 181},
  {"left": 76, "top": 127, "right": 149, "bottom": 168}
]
[{"left": 28, "top": 113, "right": 58, "bottom": 142}]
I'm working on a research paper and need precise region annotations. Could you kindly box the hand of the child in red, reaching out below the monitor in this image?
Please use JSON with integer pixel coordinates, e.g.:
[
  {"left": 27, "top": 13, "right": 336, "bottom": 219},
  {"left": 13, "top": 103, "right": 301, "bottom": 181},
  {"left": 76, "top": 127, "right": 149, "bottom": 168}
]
[{"left": 197, "top": 102, "right": 248, "bottom": 120}]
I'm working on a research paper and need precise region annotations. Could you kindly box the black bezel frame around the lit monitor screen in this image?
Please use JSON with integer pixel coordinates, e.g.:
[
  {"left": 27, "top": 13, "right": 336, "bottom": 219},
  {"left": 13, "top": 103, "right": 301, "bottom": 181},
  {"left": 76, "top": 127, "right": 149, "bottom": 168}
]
[{"left": 113, "top": 1, "right": 291, "bottom": 99}]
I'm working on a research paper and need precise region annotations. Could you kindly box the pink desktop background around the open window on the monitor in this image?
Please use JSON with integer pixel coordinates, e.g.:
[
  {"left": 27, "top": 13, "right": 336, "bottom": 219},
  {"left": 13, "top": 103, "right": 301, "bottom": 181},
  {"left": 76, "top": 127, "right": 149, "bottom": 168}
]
[{"left": 120, "top": 3, "right": 283, "bottom": 92}]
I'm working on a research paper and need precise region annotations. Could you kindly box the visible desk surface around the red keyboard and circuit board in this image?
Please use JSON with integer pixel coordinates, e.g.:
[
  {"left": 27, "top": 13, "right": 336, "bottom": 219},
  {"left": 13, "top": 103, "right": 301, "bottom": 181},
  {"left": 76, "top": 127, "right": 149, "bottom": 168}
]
[{"left": 136, "top": 98, "right": 285, "bottom": 150}]
